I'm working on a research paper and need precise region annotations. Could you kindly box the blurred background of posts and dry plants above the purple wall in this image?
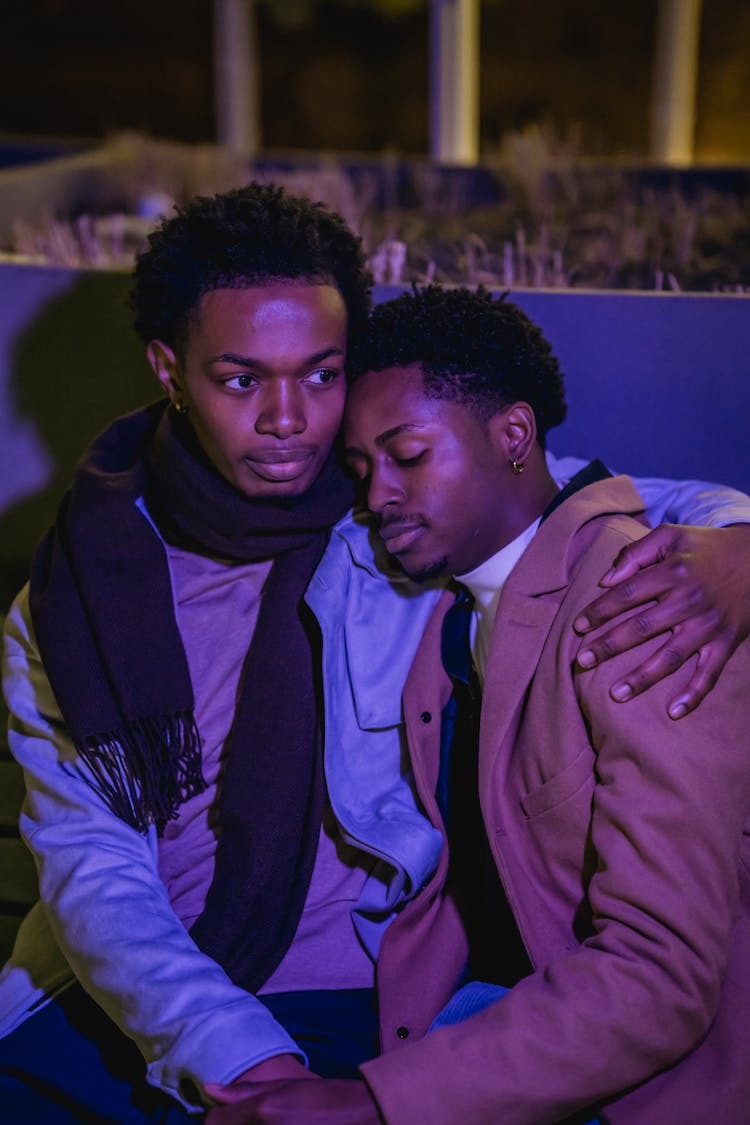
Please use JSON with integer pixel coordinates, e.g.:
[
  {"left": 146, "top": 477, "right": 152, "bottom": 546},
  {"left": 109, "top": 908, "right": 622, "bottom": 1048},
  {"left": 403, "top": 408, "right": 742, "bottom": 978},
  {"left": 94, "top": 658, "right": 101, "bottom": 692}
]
[{"left": 0, "top": 0, "right": 750, "bottom": 293}]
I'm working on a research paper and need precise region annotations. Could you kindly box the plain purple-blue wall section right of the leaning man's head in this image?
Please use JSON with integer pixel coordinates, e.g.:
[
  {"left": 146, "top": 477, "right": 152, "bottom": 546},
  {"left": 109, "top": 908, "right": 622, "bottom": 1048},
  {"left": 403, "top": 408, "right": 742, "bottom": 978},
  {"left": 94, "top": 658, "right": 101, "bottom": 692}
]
[{"left": 510, "top": 293, "right": 750, "bottom": 492}]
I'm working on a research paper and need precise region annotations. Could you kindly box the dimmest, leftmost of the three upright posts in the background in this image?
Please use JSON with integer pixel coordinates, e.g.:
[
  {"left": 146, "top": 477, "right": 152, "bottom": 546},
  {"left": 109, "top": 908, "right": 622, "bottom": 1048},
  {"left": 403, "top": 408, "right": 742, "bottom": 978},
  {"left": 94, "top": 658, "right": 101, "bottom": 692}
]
[{"left": 214, "top": 0, "right": 261, "bottom": 154}]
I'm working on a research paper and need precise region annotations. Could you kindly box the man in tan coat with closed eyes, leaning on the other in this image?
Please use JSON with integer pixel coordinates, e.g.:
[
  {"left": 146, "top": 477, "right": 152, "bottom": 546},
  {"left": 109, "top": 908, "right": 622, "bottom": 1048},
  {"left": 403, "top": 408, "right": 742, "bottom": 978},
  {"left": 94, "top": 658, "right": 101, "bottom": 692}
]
[{"left": 210, "top": 288, "right": 750, "bottom": 1125}]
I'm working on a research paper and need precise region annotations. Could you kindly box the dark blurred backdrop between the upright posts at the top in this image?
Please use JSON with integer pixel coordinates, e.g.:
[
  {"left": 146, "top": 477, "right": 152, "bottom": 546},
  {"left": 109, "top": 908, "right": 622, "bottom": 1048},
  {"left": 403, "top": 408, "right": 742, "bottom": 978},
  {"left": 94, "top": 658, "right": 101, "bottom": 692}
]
[{"left": 0, "top": 0, "right": 750, "bottom": 164}]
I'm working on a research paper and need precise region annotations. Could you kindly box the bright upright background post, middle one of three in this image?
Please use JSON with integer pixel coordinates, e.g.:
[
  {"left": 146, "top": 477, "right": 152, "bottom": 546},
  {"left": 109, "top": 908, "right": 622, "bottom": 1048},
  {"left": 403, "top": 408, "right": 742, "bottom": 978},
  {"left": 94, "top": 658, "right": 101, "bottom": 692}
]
[{"left": 430, "top": 0, "right": 479, "bottom": 164}]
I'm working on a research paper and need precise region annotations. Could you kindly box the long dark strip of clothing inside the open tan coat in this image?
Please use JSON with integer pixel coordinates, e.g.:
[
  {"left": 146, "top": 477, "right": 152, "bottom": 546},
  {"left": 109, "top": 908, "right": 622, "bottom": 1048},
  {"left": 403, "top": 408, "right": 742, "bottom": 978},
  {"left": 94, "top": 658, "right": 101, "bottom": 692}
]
[{"left": 436, "top": 586, "right": 531, "bottom": 987}]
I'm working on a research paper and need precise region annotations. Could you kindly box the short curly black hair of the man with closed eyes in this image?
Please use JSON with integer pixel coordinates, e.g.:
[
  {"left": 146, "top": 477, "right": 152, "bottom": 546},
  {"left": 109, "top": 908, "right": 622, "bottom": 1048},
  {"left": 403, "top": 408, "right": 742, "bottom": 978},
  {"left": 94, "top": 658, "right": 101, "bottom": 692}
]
[{"left": 347, "top": 285, "right": 567, "bottom": 444}]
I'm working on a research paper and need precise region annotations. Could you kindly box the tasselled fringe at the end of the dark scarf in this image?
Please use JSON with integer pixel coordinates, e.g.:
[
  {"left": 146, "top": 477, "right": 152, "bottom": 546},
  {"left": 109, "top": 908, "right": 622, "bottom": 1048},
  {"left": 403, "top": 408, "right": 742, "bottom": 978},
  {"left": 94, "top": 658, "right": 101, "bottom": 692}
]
[{"left": 76, "top": 711, "right": 207, "bottom": 836}]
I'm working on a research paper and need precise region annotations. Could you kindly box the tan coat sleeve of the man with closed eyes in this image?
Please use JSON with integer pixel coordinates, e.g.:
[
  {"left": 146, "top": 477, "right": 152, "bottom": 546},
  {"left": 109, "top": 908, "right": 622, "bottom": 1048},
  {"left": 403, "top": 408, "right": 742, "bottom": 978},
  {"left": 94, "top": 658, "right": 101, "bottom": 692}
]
[{"left": 362, "top": 540, "right": 750, "bottom": 1125}]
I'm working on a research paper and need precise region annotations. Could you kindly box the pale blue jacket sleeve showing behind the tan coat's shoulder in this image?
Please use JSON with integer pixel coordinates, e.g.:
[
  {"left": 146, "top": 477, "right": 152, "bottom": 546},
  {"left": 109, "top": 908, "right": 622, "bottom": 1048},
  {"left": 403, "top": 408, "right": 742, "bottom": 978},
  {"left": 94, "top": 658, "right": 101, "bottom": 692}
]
[{"left": 546, "top": 452, "right": 750, "bottom": 528}]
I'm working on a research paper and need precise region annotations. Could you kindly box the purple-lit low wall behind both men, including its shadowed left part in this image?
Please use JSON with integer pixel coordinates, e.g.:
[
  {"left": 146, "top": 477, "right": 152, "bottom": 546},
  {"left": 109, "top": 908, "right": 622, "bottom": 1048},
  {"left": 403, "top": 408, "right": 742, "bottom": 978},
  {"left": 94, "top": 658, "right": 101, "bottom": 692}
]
[{"left": 0, "top": 263, "right": 750, "bottom": 612}]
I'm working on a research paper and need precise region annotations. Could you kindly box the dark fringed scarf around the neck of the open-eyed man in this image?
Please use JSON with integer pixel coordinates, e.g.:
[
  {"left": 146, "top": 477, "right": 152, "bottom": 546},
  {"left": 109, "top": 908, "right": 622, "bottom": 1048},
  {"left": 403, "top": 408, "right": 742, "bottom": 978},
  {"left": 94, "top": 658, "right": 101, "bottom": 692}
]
[{"left": 30, "top": 402, "right": 353, "bottom": 990}]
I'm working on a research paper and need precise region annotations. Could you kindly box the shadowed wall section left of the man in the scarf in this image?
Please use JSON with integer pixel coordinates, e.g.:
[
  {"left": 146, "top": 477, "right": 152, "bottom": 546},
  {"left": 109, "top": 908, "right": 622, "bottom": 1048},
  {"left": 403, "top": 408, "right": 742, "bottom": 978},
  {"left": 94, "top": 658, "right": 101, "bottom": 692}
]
[{"left": 0, "top": 267, "right": 160, "bottom": 611}]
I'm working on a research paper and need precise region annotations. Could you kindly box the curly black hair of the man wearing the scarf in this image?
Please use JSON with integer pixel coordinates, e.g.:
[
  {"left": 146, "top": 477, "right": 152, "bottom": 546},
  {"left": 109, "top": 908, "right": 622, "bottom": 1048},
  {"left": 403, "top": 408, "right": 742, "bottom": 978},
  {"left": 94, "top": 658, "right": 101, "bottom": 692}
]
[{"left": 130, "top": 181, "right": 372, "bottom": 352}]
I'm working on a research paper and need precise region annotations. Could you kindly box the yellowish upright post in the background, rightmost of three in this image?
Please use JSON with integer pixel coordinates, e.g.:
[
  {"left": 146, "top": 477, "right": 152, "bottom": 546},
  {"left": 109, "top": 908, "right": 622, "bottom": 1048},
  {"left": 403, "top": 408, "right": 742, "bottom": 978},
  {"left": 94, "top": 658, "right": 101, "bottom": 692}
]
[{"left": 651, "top": 0, "right": 701, "bottom": 164}]
